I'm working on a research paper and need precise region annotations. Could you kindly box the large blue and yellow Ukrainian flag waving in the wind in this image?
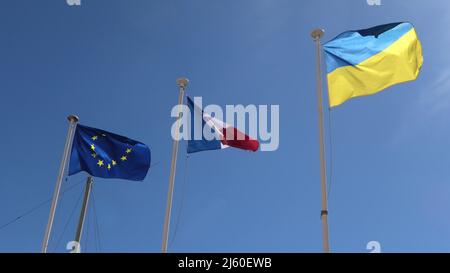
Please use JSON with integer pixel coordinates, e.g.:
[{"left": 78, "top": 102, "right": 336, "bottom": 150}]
[{"left": 323, "top": 23, "right": 423, "bottom": 107}]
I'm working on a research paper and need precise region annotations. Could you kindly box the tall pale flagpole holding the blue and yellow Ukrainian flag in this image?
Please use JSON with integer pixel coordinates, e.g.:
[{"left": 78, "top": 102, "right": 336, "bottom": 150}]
[{"left": 311, "top": 29, "right": 330, "bottom": 253}]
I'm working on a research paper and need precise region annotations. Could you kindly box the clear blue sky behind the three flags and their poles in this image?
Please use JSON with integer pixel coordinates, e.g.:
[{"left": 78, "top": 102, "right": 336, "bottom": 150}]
[{"left": 0, "top": 0, "right": 450, "bottom": 252}]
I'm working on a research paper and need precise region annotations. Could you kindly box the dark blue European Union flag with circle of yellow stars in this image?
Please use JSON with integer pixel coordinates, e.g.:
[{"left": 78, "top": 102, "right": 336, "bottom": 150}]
[{"left": 69, "top": 124, "right": 151, "bottom": 181}]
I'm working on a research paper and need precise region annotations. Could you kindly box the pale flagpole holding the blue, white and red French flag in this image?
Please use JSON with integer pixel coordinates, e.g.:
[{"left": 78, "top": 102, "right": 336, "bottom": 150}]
[{"left": 161, "top": 78, "right": 189, "bottom": 253}]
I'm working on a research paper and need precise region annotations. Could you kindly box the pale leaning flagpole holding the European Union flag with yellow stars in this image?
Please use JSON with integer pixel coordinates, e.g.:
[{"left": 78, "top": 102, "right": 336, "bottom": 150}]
[{"left": 41, "top": 115, "right": 78, "bottom": 253}]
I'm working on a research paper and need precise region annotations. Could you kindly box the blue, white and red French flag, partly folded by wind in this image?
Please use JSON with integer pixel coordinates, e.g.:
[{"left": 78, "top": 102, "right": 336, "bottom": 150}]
[{"left": 187, "top": 97, "right": 259, "bottom": 153}]
